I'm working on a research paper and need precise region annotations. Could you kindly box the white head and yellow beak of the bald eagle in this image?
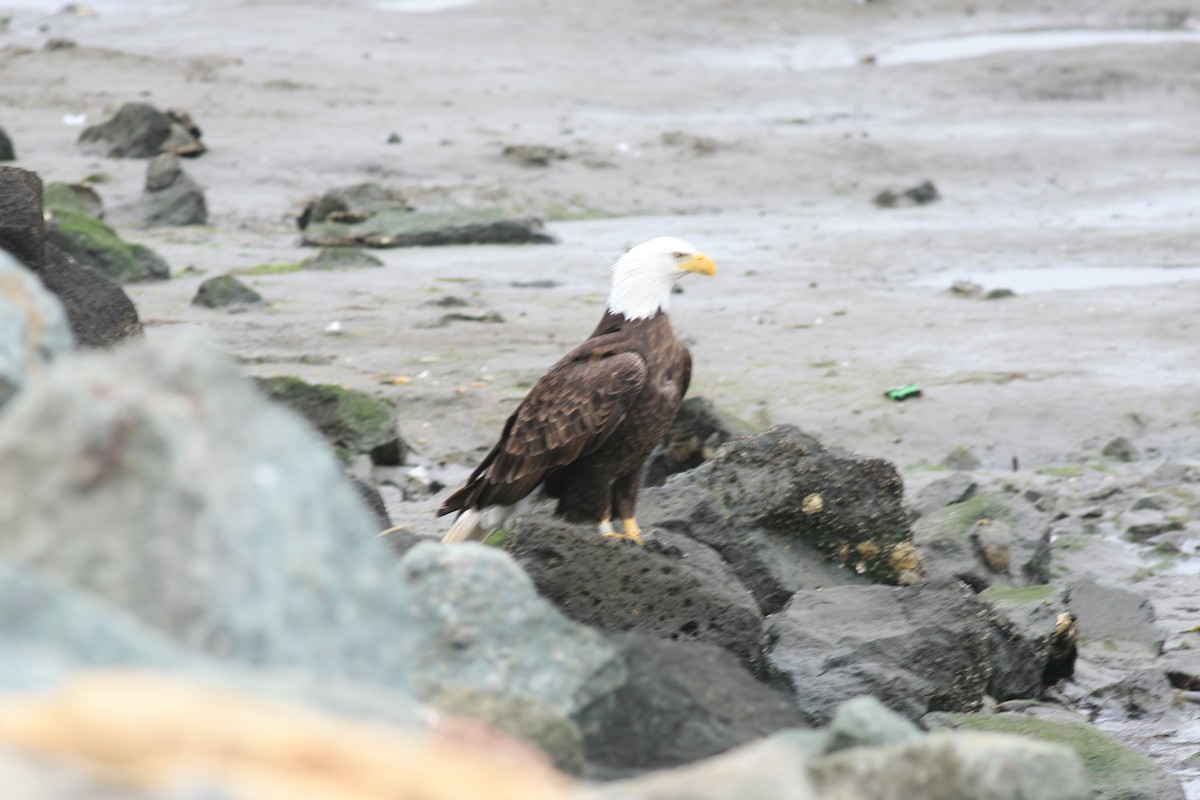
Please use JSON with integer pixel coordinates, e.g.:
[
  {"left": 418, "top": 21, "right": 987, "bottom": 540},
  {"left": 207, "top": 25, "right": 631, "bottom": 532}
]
[{"left": 608, "top": 236, "right": 716, "bottom": 319}]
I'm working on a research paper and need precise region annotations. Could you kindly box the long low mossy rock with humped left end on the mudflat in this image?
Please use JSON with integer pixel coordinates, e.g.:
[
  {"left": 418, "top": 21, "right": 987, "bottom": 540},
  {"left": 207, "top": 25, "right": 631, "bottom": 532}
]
[{"left": 299, "top": 184, "right": 554, "bottom": 247}]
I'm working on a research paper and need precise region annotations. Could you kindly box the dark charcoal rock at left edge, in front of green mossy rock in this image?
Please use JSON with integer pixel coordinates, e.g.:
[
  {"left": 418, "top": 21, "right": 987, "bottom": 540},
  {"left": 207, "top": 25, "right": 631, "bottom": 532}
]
[{"left": 0, "top": 167, "right": 142, "bottom": 347}]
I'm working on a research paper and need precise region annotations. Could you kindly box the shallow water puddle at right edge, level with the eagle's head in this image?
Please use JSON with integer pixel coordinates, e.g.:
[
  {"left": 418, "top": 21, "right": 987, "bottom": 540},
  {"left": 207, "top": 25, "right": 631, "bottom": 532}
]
[{"left": 914, "top": 266, "right": 1200, "bottom": 294}]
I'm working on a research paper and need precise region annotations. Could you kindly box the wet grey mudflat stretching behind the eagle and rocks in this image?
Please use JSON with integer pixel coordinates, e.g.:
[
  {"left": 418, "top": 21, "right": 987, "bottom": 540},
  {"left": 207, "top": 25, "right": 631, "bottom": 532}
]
[{"left": 0, "top": 0, "right": 1200, "bottom": 786}]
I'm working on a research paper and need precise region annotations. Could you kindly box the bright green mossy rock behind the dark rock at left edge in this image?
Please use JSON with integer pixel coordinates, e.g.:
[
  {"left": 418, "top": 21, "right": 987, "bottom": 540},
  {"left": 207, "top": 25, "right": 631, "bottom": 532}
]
[{"left": 46, "top": 188, "right": 170, "bottom": 283}]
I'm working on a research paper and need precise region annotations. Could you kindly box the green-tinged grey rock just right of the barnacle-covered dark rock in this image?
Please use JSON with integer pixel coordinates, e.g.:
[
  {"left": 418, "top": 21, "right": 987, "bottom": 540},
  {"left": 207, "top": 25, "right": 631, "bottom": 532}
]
[{"left": 913, "top": 494, "right": 1051, "bottom": 591}]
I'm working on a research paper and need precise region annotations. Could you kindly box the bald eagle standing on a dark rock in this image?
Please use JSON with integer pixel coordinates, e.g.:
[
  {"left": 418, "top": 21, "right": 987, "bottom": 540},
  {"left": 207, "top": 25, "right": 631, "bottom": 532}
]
[{"left": 438, "top": 236, "right": 716, "bottom": 543}]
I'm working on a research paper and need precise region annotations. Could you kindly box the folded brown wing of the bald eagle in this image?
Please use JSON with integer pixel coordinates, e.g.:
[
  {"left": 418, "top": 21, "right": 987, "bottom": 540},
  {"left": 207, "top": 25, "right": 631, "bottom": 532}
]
[{"left": 438, "top": 337, "right": 646, "bottom": 517}]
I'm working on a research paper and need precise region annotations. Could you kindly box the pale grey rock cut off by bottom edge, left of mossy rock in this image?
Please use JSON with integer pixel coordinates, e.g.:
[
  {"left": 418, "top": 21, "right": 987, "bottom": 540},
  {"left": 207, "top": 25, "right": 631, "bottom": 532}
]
[{"left": 809, "top": 733, "right": 1092, "bottom": 800}]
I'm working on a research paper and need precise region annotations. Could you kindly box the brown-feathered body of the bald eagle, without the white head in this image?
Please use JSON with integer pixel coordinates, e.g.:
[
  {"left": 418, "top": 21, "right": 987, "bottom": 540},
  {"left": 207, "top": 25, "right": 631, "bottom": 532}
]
[{"left": 438, "top": 309, "right": 691, "bottom": 523}]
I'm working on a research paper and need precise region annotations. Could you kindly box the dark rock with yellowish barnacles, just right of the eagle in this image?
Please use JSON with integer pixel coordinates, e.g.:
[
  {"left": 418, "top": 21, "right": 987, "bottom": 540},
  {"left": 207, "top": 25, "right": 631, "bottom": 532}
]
[{"left": 679, "top": 426, "right": 920, "bottom": 583}]
